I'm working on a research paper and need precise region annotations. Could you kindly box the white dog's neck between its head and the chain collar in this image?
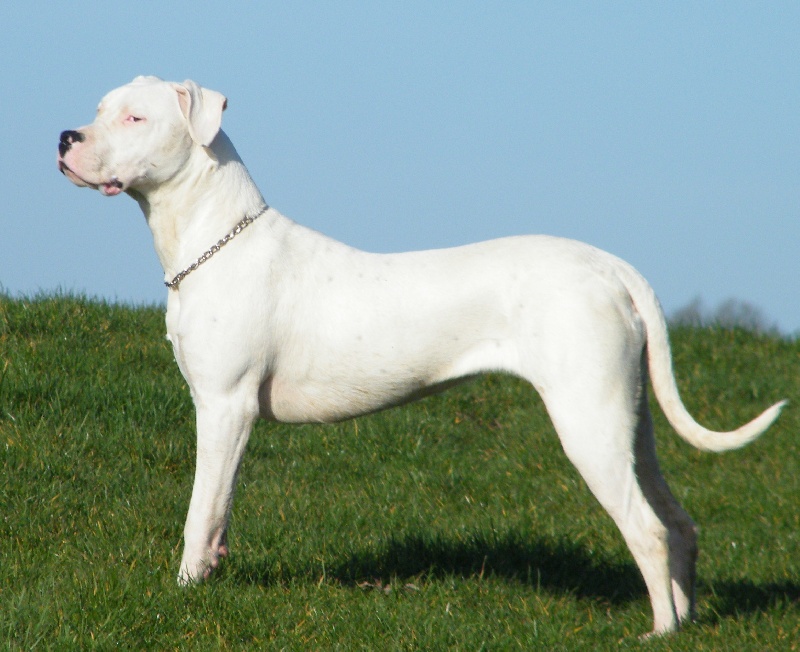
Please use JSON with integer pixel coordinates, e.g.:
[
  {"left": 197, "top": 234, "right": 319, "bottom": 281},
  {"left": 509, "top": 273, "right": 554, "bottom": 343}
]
[{"left": 128, "top": 131, "right": 265, "bottom": 279}]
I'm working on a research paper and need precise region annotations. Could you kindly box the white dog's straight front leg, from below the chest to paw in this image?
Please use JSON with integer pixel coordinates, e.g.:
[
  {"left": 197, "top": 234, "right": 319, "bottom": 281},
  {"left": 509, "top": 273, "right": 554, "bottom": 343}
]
[{"left": 178, "top": 396, "right": 257, "bottom": 584}]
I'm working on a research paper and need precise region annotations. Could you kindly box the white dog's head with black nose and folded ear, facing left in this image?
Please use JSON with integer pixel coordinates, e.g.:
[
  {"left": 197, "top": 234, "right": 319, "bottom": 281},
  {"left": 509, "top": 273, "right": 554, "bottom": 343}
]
[{"left": 57, "top": 77, "right": 227, "bottom": 196}]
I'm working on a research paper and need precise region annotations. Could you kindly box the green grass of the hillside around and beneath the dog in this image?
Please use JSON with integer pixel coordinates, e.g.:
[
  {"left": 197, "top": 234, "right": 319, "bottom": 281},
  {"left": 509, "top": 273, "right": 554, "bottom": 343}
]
[{"left": 0, "top": 297, "right": 800, "bottom": 651}]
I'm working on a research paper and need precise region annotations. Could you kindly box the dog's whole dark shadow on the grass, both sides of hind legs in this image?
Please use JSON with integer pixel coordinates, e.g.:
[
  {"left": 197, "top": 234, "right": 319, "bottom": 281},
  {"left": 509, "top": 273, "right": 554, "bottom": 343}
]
[{"left": 234, "top": 532, "right": 800, "bottom": 624}]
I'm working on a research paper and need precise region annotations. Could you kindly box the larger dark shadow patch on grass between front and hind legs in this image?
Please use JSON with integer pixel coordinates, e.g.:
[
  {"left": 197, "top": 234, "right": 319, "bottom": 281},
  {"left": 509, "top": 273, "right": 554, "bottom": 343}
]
[{"left": 237, "top": 532, "right": 646, "bottom": 604}]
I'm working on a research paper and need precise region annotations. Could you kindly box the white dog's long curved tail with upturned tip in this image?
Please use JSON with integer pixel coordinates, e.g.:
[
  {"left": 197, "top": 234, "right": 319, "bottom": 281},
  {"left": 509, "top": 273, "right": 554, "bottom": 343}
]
[{"left": 621, "top": 262, "right": 786, "bottom": 453}]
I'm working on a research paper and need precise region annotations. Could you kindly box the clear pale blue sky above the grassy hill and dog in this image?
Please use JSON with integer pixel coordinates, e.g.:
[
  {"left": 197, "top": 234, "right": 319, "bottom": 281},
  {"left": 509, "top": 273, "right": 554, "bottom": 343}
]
[{"left": 0, "top": 1, "right": 800, "bottom": 333}]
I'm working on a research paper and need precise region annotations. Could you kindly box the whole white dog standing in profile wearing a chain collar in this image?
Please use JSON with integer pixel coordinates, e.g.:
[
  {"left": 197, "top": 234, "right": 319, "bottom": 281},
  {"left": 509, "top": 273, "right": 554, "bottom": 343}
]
[{"left": 58, "top": 77, "right": 783, "bottom": 633}]
